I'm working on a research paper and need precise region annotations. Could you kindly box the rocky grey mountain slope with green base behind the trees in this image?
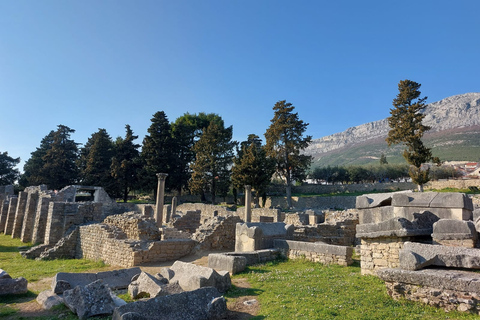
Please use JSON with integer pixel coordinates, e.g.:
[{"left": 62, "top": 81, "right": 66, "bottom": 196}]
[{"left": 305, "top": 93, "right": 480, "bottom": 166}]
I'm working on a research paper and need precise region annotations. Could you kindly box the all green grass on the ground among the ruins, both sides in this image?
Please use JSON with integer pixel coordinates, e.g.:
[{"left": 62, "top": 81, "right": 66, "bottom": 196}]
[{"left": 0, "top": 234, "right": 478, "bottom": 320}]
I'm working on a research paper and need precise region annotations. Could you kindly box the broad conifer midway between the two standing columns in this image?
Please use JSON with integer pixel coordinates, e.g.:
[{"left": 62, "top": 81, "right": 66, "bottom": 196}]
[{"left": 189, "top": 122, "right": 235, "bottom": 204}]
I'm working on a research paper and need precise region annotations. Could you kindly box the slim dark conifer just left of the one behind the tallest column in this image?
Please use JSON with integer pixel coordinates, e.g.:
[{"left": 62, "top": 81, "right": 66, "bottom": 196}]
[{"left": 111, "top": 124, "right": 141, "bottom": 202}]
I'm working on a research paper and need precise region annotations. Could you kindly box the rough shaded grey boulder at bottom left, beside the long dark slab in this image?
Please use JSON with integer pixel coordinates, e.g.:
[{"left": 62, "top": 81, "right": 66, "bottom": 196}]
[{"left": 63, "top": 280, "right": 117, "bottom": 319}]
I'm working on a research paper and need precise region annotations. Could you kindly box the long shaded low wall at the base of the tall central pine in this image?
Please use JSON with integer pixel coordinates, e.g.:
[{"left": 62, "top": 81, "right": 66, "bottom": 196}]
[{"left": 265, "top": 196, "right": 356, "bottom": 210}]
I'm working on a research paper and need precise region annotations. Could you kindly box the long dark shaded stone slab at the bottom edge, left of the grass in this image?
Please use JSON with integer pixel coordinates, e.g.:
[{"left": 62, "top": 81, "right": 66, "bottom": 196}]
[{"left": 112, "top": 287, "right": 227, "bottom": 320}]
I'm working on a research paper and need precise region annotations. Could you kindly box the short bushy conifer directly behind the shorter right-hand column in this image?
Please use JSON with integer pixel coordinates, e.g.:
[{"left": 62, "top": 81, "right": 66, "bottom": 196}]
[{"left": 232, "top": 134, "right": 275, "bottom": 205}]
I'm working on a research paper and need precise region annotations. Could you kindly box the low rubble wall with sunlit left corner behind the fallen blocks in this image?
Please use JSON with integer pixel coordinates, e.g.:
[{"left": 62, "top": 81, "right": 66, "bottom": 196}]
[{"left": 75, "top": 224, "right": 195, "bottom": 268}]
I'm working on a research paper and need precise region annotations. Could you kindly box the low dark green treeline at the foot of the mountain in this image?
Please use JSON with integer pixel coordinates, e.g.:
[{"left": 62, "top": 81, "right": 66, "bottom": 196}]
[{"left": 309, "top": 164, "right": 460, "bottom": 184}]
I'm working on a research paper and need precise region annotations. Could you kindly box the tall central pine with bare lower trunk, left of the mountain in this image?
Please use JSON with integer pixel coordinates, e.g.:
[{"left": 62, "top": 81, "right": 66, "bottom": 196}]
[{"left": 265, "top": 100, "right": 312, "bottom": 208}]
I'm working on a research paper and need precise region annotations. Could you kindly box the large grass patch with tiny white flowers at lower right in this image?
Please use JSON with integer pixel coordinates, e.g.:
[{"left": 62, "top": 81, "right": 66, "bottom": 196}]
[{"left": 226, "top": 260, "right": 478, "bottom": 320}]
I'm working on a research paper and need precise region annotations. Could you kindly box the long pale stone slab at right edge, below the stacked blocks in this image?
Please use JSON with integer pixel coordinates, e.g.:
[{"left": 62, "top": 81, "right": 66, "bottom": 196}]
[{"left": 400, "top": 242, "right": 480, "bottom": 270}]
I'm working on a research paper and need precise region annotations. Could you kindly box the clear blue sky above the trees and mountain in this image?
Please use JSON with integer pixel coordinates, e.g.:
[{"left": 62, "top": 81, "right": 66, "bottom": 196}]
[{"left": 0, "top": 0, "right": 480, "bottom": 168}]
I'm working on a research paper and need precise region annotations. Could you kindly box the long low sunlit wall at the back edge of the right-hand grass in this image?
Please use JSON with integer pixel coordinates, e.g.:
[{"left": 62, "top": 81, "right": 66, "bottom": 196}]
[{"left": 274, "top": 240, "right": 353, "bottom": 266}]
